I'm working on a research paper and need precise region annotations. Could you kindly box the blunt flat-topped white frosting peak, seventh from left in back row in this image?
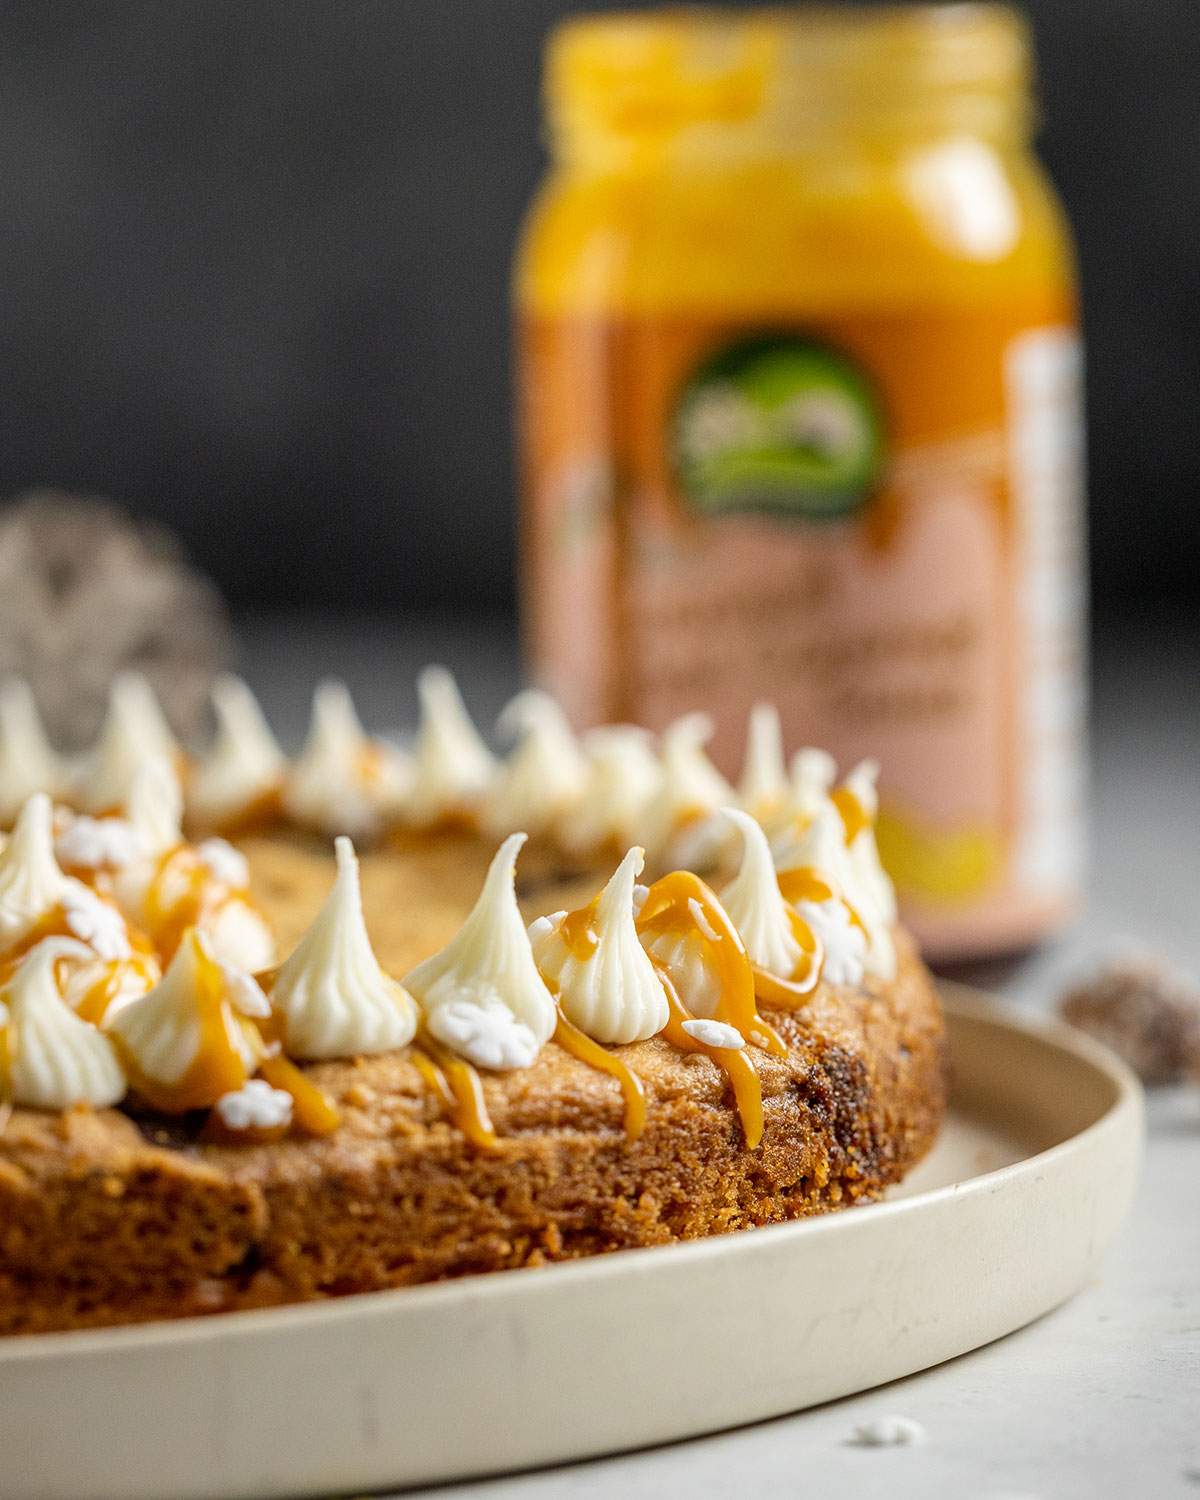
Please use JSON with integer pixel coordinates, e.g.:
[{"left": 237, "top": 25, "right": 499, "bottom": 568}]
[{"left": 557, "top": 725, "right": 662, "bottom": 857}]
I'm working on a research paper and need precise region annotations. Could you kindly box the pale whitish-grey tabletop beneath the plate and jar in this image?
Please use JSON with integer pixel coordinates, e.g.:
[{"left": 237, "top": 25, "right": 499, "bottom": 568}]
[{"left": 243, "top": 618, "right": 1200, "bottom": 1500}]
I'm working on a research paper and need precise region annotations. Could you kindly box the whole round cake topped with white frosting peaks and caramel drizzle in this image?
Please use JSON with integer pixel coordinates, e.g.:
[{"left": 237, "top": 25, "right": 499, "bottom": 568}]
[{"left": 0, "top": 671, "right": 945, "bottom": 1334}]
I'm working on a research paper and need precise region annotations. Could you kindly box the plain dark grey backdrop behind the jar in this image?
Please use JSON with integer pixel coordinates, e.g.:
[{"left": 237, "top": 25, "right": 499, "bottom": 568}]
[{"left": 0, "top": 0, "right": 1200, "bottom": 608}]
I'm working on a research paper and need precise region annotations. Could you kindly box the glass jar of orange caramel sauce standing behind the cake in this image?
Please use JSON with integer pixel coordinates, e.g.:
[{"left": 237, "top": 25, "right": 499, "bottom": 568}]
[{"left": 516, "top": 5, "right": 1083, "bottom": 959}]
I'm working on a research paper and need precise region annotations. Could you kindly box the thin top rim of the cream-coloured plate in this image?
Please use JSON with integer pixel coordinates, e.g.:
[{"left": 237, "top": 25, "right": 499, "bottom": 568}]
[{"left": 0, "top": 980, "right": 1145, "bottom": 1368}]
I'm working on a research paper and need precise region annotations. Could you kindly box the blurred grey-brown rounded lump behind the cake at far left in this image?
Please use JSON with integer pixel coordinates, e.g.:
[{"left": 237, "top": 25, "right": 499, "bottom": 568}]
[{"left": 0, "top": 489, "right": 233, "bottom": 749}]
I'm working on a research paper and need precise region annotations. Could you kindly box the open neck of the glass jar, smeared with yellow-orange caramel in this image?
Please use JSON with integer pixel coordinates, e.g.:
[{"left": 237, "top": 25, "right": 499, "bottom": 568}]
[{"left": 546, "top": 5, "right": 1031, "bottom": 161}]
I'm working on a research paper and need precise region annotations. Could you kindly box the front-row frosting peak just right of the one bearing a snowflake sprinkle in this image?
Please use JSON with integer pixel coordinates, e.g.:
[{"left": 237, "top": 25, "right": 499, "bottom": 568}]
[{"left": 530, "top": 848, "right": 669, "bottom": 1044}]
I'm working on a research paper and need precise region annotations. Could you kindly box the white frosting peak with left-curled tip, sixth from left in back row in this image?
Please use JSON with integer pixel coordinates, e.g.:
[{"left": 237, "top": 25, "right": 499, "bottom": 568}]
[{"left": 480, "top": 689, "right": 588, "bottom": 839}]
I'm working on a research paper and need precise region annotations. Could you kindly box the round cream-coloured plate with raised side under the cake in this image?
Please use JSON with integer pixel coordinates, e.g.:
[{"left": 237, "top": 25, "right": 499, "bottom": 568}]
[{"left": 0, "top": 987, "right": 1142, "bottom": 1500}]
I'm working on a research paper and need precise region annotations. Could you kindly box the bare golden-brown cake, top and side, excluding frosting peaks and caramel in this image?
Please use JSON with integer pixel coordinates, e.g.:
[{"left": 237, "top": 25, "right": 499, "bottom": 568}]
[{"left": 0, "top": 669, "right": 945, "bottom": 1334}]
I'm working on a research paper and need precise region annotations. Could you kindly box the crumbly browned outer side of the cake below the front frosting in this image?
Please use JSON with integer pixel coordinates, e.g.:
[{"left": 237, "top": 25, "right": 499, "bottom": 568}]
[{"left": 0, "top": 933, "right": 947, "bottom": 1335}]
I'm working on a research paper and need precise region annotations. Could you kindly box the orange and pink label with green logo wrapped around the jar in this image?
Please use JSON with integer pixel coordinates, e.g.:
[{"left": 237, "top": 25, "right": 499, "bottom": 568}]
[{"left": 522, "top": 306, "right": 1083, "bottom": 954}]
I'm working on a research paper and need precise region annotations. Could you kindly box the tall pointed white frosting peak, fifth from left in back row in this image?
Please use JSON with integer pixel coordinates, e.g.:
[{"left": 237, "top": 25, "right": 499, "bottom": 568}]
[{"left": 405, "top": 666, "right": 497, "bottom": 828}]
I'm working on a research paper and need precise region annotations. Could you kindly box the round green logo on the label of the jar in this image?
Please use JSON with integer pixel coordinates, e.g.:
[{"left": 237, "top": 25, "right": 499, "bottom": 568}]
[{"left": 674, "top": 333, "right": 884, "bottom": 521}]
